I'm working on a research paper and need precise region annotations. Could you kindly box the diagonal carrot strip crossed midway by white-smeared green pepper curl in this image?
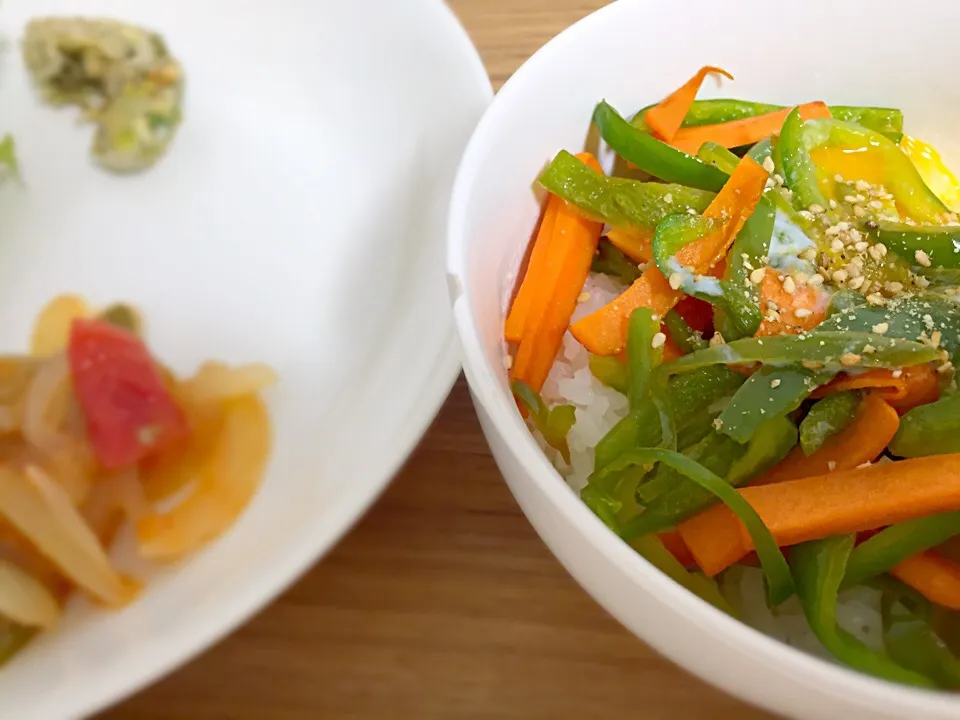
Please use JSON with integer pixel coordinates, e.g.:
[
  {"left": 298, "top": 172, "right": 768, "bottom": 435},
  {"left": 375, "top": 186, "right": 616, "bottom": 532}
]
[{"left": 570, "top": 157, "right": 767, "bottom": 355}]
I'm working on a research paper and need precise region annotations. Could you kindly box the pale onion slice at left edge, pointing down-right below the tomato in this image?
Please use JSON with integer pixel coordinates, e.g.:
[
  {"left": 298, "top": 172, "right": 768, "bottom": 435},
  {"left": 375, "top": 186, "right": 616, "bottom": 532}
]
[{"left": 0, "top": 466, "right": 137, "bottom": 606}]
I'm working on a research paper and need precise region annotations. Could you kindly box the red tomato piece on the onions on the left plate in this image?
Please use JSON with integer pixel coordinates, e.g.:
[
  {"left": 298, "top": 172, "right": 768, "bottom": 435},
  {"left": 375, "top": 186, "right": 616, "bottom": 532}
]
[{"left": 67, "top": 320, "right": 188, "bottom": 469}]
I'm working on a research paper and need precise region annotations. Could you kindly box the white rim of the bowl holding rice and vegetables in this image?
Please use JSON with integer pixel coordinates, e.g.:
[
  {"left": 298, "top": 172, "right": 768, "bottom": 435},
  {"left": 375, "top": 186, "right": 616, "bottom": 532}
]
[{"left": 447, "top": 0, "right": 960, "bottom": 717}]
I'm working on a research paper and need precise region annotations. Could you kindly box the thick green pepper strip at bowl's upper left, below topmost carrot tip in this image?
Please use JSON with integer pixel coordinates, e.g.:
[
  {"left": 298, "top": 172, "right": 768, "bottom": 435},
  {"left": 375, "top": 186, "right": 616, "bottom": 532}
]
[{"left": 593, "top": 102, "right": 729, "bottom": 192}]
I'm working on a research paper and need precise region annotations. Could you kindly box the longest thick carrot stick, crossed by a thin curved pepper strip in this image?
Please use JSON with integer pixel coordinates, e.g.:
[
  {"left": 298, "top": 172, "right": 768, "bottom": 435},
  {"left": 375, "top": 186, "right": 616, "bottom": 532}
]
[{"left": 677, "top": 454, "right": 960, "bottom": 575}]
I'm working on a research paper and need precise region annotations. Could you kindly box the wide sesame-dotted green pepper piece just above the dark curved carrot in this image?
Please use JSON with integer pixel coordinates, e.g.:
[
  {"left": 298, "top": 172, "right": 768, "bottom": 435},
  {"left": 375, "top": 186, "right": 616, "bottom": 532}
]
[{"left": 717, "top": 365, "right": 833, "bottom": 443}]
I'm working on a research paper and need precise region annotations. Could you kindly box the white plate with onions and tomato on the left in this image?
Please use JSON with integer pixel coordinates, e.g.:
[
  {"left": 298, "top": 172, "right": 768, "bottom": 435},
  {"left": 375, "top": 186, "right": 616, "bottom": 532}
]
[{"left": 0, "top": 0, "right": 492, "bottom": 719}]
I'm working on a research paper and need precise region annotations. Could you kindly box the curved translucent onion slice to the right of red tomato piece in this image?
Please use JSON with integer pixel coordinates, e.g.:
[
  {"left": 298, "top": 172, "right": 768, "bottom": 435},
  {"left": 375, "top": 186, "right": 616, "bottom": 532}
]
[{"left": 137, "top": 395, "right": 271, "bottom": 560}]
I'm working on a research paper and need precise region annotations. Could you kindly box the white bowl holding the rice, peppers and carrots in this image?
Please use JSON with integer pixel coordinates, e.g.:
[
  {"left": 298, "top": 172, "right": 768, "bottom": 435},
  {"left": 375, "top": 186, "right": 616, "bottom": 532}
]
[{"left": 448, "top": 0, "right": 960, "bottom": 720}]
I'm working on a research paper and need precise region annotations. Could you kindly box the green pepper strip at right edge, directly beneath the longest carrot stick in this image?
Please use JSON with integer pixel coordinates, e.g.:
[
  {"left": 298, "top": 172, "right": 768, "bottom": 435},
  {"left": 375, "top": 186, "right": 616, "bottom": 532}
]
[{"left": 842, "top": 512, "right": 960, "bottom": 588}]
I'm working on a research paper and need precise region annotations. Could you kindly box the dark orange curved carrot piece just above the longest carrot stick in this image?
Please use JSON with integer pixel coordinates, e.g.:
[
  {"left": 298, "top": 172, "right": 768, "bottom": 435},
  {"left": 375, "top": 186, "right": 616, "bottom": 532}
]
[{"left": 755, "top": 393, "right": 900, "bottom": 485}]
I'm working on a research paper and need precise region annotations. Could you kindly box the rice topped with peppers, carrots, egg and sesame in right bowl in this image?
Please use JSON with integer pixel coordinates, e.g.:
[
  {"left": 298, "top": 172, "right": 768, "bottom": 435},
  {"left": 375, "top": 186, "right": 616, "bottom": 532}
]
[{"left": 504, "top": 67, "right": 960, "bottom": 689}]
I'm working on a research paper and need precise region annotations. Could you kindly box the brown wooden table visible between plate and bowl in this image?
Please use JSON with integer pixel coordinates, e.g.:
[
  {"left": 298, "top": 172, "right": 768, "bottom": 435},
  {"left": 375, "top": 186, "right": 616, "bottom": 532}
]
[{"left": 101, "top": 0, "right": 768, "bottom": 720}]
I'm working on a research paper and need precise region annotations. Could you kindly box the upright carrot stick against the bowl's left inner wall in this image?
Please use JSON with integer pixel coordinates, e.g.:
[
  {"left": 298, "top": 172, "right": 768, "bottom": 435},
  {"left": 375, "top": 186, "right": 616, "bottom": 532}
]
[{"left": 513, "top": 153, "right": 603, "bottom": 391}]
